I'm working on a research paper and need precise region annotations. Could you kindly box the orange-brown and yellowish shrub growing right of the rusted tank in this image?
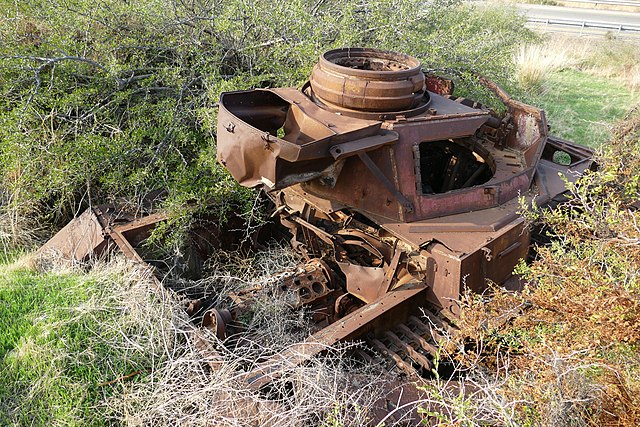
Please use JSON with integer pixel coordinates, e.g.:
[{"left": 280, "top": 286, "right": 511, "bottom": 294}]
[{"left": 452, "top": 110, "right": 640, "bottom": 426}]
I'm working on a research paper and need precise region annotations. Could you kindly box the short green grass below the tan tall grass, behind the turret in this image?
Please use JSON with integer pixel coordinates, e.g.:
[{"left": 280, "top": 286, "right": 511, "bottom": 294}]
[{"left": 528, "top": 69, "right": 640, "bottom": 147}]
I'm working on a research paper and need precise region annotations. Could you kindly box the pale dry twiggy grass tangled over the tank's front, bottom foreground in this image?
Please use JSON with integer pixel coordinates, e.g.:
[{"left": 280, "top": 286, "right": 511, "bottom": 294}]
[{"left": 81, "top": 250, "right": 396, "bottom": 426}]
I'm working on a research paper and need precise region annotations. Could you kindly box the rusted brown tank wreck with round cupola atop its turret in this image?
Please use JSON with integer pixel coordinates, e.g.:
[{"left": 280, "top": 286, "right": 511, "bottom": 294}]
[{"left": 212, "top": 48, "right": 592, "bottom": 387}]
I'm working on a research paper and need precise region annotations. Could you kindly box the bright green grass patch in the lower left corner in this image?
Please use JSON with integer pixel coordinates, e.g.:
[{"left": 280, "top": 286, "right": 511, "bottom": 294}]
[{"left": 0, "top": 265, "right": 165, "bottom": 426}]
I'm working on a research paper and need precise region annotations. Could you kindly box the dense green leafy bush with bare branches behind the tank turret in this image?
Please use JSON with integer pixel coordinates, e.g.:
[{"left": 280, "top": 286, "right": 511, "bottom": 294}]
[{"left": 0, "top": 0, "right": 531, "bottom": 237}]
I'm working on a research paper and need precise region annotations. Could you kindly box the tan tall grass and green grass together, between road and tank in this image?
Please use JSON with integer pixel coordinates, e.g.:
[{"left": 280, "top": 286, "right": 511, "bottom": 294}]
[{"left": 514, "top": 35, "right": 640, "bottom": 147}]
